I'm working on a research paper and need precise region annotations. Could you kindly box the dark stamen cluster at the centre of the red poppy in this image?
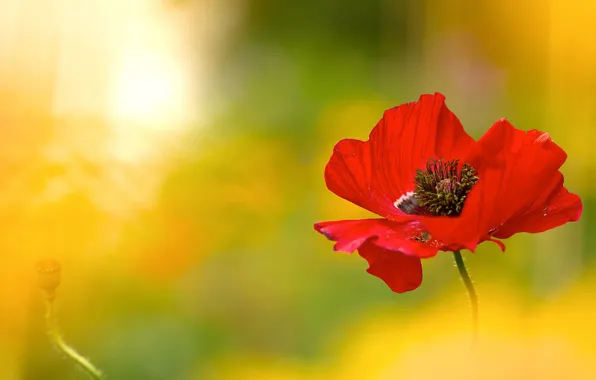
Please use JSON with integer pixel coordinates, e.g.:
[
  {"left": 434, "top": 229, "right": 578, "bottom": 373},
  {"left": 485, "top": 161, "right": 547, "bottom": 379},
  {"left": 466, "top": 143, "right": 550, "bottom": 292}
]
[{"left": 414, "top": 159, "right": 478, "bottom": 216}]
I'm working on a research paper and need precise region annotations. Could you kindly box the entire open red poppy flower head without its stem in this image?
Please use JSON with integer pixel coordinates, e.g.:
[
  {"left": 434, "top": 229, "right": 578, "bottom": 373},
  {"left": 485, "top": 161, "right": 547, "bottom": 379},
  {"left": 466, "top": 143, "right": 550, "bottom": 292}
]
[{"left": 314, "top": 93, "right": 582, "bottom": 293}]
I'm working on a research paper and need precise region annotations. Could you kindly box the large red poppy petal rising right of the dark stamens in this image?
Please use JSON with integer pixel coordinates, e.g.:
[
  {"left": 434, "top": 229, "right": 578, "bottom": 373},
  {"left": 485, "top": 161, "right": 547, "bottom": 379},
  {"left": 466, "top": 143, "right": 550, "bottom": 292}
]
[{"left": 421, "top": 119, "right": 571, "bottom": 250}]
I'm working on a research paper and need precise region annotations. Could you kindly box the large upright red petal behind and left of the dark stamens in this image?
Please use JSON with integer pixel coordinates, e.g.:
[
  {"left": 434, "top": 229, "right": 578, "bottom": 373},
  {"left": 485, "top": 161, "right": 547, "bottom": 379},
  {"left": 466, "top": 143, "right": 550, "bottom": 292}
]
[{"left": 325, "top": 93, "right": 475, "bottom": 218}]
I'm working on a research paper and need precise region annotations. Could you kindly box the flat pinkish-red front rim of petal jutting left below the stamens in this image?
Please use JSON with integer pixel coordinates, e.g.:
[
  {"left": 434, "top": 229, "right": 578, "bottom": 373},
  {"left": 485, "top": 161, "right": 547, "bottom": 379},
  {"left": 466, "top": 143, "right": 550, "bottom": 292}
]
[{"left": 315, "top": 217, "right": 438, "bottom": 257}]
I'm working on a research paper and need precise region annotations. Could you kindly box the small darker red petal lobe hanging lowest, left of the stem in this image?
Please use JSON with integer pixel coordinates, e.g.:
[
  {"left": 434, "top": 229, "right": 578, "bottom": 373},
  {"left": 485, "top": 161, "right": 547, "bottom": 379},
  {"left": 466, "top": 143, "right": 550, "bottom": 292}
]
[{"left": 358, "top": 243, "right": 422, "bottom": 293}]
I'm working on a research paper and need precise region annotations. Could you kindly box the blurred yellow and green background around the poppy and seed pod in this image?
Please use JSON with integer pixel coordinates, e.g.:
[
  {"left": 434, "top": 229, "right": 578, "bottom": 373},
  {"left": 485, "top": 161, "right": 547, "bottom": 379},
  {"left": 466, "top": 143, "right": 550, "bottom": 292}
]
[{"left": 0, "top": 0, "right": 596, "bottom": 380}]
